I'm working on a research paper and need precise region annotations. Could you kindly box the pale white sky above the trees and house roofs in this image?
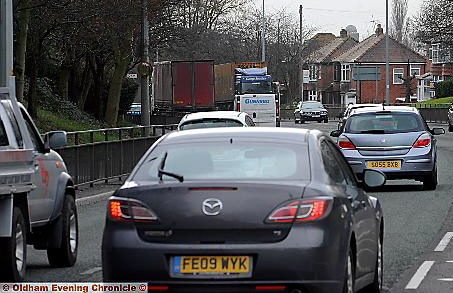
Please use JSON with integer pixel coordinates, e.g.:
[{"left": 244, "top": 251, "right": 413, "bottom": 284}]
[{"left": 254, "top": 0, "right": 423, "bottom": 40}]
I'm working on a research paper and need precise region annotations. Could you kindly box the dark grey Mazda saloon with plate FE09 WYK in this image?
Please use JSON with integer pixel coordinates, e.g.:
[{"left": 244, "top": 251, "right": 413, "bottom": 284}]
[{"left": 102, "top": 128, "right": 385, "bottom": 293}]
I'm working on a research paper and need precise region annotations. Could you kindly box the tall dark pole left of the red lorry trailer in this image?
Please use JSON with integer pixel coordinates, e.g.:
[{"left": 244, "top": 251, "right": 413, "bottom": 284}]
[{"left": 138, "top": 0, "right": 151, "bottom": 133}]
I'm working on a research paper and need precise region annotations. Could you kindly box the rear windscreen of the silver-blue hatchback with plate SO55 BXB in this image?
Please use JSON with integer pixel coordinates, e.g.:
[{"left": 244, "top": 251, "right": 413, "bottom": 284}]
[{"left": 345, "top": 113, "right": 425, "bottom": 134}]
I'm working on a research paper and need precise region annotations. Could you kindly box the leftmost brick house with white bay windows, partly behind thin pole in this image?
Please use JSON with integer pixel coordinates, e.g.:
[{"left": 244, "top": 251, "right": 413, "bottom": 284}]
[{"left": 303, "top": 29, "right": 358, "bottom": 104}]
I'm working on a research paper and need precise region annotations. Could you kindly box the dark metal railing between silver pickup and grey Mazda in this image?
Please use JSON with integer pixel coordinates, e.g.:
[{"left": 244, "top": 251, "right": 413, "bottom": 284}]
[{"left": 57, "top": 124, "right": 177, "bottom": 186}]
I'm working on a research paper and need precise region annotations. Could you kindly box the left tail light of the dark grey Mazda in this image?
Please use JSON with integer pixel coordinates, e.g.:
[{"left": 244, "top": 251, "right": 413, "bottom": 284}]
[{"left": 109, "top": 197, "right": 158, "bottom": 222}]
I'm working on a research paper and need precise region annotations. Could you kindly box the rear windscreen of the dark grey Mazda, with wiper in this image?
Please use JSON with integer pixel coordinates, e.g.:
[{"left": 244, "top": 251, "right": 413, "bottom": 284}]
[{"left": 133, "top": 138, "right": 310, "bottom": 181}]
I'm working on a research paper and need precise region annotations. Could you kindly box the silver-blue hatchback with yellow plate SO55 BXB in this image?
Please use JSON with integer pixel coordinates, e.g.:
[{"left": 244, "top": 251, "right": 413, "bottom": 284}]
[{"left": 331, "top": 106, "right": 445, "bottom": 190}]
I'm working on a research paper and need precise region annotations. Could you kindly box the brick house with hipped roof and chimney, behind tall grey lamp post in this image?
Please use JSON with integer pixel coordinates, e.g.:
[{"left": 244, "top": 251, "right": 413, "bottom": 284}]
[{"left": 332, "top": 25, "right": 427, "bottom": 103}]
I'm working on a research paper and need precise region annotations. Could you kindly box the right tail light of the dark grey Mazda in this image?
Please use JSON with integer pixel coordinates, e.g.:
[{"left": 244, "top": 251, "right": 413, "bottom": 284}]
[{"left": 267, "top": 199, "right": 332, "bottom": 223}]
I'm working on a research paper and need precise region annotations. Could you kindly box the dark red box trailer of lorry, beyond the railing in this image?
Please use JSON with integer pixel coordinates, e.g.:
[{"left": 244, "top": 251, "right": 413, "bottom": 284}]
[{"left": 152, "top": 60, "right": 215, "bottom": 112}]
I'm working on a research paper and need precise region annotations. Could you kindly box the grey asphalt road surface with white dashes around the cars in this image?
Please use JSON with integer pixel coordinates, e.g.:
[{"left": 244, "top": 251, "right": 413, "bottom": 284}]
[{"left": 27, "top": 121, "right": 453, "bottom": 293}]
